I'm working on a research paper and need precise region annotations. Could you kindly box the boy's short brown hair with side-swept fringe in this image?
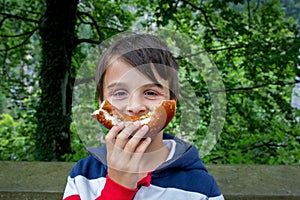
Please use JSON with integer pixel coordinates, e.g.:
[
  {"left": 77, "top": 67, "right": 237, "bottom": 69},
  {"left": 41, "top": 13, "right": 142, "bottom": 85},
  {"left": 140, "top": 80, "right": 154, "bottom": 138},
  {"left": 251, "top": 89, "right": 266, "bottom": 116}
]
[{"left": 96, "top": 33, "right": 179, "bottom": 101}]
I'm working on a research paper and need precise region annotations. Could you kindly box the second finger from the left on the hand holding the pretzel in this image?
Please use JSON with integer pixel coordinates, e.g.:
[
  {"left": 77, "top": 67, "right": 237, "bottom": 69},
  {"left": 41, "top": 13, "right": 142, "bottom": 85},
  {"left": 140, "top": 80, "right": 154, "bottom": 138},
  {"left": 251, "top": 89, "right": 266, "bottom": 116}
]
[{"left": 115, "top": 122, "right": 140, "bottom": 149}]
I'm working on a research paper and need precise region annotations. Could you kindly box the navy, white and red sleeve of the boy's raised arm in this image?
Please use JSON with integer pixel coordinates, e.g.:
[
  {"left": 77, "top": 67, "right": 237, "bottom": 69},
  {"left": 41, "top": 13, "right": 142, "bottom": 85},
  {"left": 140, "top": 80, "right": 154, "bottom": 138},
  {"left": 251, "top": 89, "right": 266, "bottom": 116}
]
[{"left": 63, "top": 156, "right": 151, "bottom": 200}]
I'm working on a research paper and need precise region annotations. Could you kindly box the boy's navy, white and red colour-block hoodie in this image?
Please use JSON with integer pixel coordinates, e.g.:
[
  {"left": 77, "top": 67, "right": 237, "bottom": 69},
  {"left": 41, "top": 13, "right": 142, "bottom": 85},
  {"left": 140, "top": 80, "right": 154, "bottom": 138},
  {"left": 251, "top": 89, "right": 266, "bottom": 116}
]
[{"left": 63, "top": 134, "right": 224, "bottom": 200}]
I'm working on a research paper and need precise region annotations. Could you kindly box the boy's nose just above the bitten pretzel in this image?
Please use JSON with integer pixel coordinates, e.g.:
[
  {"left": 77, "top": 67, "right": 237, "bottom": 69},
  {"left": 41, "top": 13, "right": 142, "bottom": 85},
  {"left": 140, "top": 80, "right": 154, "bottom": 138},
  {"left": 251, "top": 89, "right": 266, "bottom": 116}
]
[{"left": 126, "top": 95, "right": 147, "bottom": 116}]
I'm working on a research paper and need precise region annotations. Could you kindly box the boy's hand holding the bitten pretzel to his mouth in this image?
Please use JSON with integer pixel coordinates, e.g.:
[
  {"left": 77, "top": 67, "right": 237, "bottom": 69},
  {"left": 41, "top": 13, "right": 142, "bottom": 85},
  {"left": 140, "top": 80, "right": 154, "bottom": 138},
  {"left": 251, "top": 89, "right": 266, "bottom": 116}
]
[{"left": 105, "top": 121, "right": 151, "bottom": 189}]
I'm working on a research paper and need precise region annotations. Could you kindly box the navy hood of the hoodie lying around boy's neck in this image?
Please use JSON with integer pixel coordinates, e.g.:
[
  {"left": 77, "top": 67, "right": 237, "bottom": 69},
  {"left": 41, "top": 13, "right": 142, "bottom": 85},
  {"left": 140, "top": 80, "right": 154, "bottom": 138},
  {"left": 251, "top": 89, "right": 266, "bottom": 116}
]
[{"left": 87, "top": 133, "right": 207, "bottom": 174}]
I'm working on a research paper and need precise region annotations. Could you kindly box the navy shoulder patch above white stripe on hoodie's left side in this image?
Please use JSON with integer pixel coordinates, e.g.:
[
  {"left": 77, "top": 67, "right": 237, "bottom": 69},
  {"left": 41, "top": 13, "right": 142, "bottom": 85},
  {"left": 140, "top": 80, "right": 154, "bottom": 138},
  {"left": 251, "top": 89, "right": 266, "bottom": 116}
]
[{"left": 70, "top": 156, "right": 107, "bottom": 179}]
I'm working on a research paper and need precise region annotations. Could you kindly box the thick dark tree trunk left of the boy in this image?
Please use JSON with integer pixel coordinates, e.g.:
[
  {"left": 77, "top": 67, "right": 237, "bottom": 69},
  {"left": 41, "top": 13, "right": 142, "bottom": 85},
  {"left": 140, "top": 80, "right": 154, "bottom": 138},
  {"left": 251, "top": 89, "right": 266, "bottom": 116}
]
[{"left": 35, "top": 0, "right": 78, "bottom": 161}]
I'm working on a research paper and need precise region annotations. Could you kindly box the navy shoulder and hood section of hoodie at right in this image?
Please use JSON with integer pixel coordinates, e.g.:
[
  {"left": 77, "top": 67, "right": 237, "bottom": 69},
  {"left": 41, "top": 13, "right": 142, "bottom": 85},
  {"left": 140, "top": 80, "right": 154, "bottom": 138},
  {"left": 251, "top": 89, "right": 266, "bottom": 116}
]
[{"left": 156, "top": 135, "right": 221, "bottom": 197}]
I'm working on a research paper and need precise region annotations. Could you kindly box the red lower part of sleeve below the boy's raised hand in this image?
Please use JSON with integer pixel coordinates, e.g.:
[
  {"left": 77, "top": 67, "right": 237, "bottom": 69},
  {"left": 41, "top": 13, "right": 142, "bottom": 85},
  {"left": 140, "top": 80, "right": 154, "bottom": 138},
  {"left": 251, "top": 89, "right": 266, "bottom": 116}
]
[{"left": 96, "top": 175, "right": 138, "bottom": 200}]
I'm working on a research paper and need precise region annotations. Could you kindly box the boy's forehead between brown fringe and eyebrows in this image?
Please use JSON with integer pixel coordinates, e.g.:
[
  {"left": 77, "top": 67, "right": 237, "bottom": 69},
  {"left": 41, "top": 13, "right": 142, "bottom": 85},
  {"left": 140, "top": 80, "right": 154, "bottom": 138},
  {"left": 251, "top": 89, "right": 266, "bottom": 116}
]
[{"left": 104, "top": 59, "right": 168, "bottom": 89}]
